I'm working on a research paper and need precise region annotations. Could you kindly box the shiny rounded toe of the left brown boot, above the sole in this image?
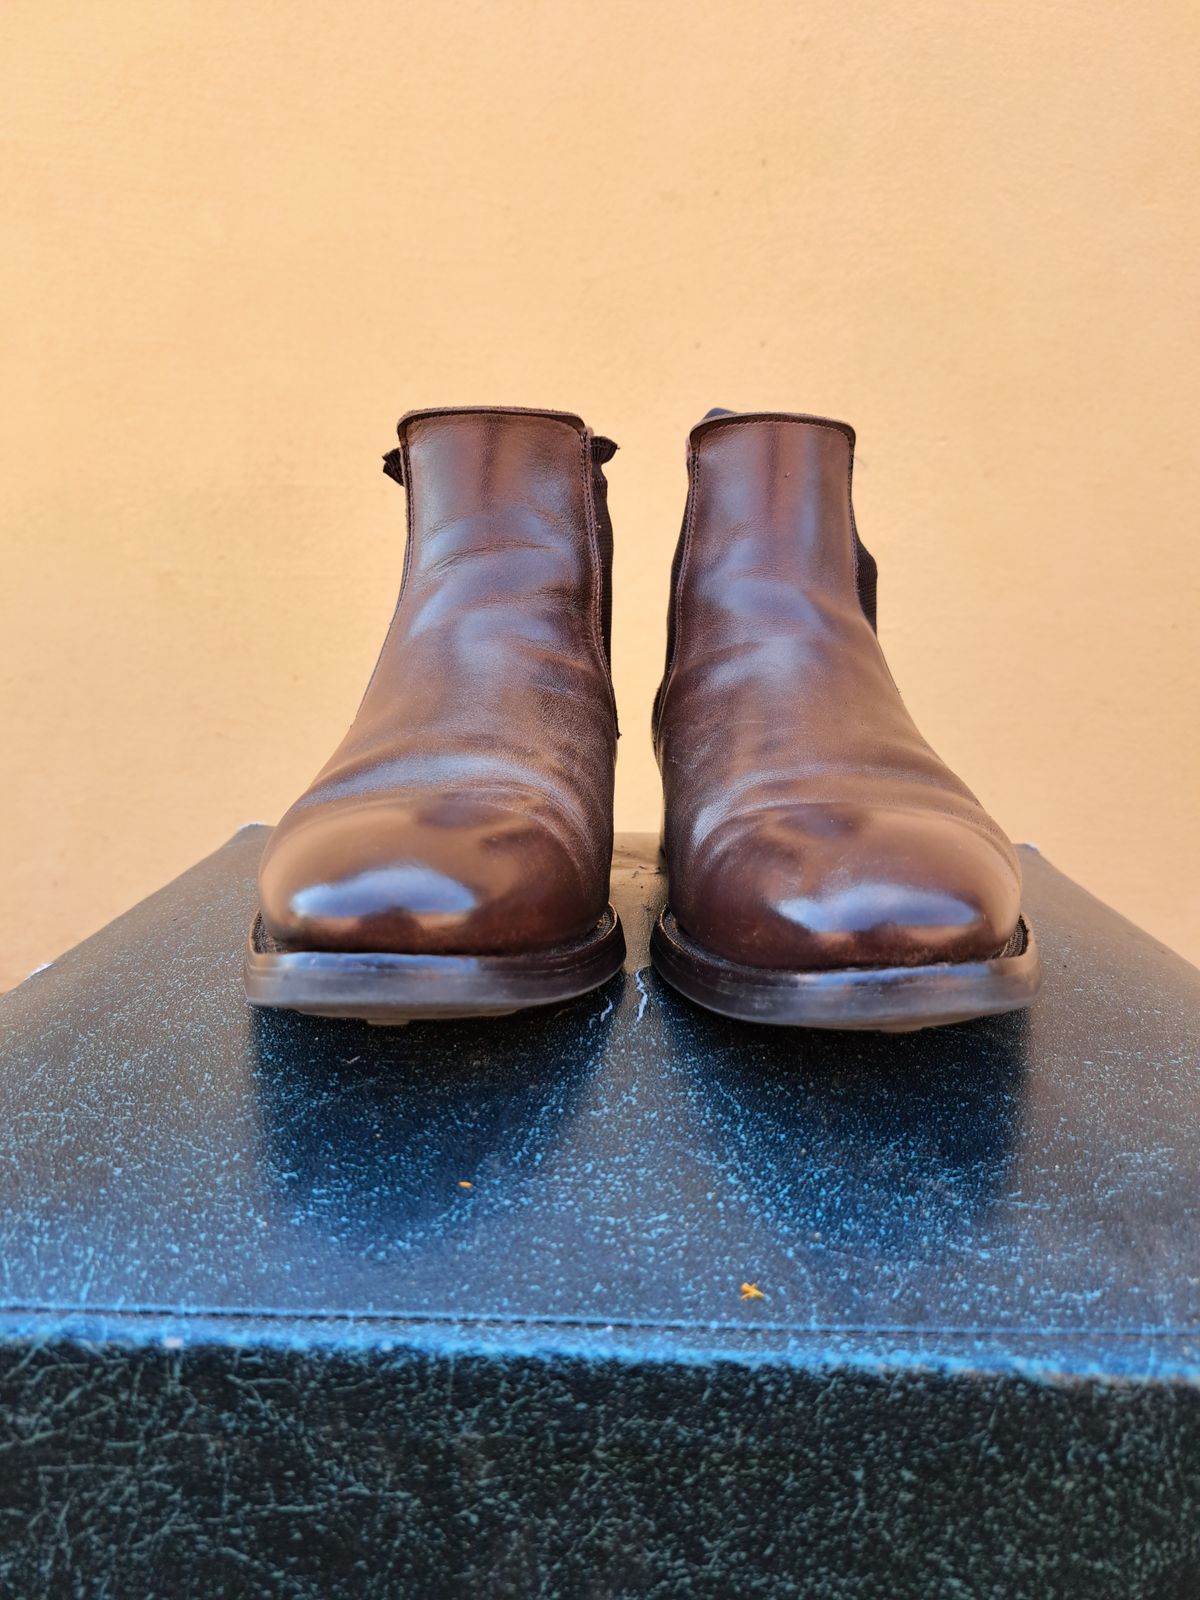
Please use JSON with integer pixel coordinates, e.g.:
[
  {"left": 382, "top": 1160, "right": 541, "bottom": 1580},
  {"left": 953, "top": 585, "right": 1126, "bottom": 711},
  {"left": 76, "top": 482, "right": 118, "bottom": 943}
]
[{"left": 259, "top": 795, "right": 603, "bottom": 955}]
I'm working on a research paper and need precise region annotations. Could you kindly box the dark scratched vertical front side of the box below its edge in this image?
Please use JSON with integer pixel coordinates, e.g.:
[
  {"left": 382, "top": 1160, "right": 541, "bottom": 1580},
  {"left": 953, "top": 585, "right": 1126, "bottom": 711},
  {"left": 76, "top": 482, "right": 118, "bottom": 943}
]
[{"left": 0, "top": 1346, "right": 1200, "bottom": 1600}]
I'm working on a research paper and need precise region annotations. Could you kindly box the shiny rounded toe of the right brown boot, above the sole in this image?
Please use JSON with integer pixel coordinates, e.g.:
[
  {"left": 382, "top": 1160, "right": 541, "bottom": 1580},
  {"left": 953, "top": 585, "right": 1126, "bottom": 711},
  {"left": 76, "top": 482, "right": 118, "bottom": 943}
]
[{"left": 672, "top": 806, "right": 1021, "bottom": 970}]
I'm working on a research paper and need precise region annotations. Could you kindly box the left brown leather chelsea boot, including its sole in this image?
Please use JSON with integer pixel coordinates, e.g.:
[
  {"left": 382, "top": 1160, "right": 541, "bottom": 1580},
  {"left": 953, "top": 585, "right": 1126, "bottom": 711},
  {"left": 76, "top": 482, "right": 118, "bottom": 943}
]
[{"left": 246, "top": 408, "right": 624, "bottom": 1022}]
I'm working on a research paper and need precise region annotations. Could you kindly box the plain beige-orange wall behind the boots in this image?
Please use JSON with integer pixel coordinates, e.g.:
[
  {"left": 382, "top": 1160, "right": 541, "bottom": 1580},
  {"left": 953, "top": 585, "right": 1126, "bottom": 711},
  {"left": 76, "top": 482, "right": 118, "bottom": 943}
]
[{"left": 0, "top": 0, "right": 1200, "bottom": 984}]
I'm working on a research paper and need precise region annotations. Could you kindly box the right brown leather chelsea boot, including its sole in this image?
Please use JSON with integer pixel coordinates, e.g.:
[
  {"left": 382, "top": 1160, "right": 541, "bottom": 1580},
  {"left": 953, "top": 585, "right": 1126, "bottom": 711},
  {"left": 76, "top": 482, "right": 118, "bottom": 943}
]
[{"left": 651, "top": 413, "right": 1038, "bottom": 1029}]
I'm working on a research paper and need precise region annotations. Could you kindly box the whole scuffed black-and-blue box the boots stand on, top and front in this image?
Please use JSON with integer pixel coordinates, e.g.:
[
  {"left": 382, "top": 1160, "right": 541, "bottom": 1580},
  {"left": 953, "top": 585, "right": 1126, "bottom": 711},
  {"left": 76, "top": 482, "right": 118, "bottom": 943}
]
[{"left": 0, "top": 829, "right": 1200, "bottom": 1600}]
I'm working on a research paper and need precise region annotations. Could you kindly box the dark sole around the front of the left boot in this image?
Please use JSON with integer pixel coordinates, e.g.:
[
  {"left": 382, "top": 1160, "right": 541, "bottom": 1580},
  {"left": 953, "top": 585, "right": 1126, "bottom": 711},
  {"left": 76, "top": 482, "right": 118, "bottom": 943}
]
[{"left": 245, "top": 906, "right": 626, "bottom": 1026}]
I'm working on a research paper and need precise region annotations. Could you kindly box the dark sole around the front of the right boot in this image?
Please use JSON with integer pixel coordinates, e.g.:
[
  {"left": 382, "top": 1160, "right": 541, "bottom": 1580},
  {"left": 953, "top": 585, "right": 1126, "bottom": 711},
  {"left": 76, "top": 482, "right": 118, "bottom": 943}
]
[{"left": 650, "top": 907, "right": 1042, "bottom": 1034}]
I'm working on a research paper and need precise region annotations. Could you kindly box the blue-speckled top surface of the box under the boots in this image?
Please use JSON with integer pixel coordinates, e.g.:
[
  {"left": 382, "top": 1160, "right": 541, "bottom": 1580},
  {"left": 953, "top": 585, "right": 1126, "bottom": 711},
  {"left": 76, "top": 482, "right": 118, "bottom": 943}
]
[{"left": 0, "top": 827, "right": 1200, "bottom": 1378}]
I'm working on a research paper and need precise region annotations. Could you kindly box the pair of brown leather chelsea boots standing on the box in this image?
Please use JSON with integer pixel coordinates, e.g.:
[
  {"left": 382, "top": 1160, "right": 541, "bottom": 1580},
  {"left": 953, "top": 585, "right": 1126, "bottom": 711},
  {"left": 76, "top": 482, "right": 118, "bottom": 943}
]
[{"left": 246, "top": 408, "right": 1038, "bottom": 1029}]
